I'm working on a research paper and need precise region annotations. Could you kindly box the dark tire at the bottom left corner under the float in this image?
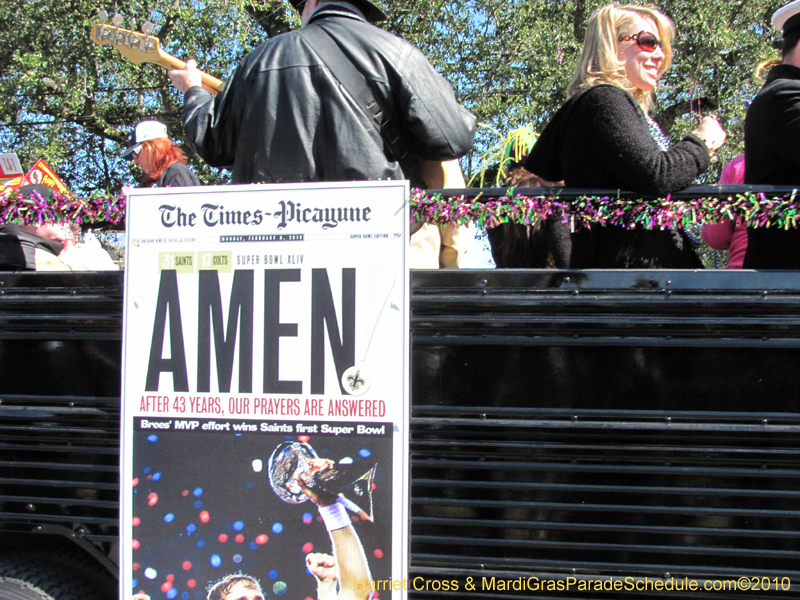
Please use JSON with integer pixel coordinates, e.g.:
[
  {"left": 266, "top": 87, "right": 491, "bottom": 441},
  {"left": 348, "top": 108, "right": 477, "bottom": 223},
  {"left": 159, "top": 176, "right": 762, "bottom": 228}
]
[{"left": 0, "top": 555, "right": 108, "bottom": 600}]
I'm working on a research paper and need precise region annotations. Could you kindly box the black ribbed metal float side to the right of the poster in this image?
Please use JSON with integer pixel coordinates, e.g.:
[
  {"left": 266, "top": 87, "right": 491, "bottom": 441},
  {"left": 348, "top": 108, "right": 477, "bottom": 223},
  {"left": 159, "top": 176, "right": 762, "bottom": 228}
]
[{"left": 411, "top": 272, "right": 800, "bottom": 598}]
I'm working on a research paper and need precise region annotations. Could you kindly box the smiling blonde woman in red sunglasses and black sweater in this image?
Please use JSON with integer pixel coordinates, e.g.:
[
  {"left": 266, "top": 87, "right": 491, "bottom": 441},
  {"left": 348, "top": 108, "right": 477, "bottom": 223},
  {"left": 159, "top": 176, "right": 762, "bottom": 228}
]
[{"left": 525, "top": 4, "right": 725, "bottom": 269}]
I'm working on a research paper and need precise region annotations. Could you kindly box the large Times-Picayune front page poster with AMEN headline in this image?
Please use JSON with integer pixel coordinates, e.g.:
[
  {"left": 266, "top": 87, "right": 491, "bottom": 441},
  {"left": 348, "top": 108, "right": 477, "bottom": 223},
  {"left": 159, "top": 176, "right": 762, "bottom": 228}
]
[{"left": 120, "top": 182, "right": 409, "bottom": 600}]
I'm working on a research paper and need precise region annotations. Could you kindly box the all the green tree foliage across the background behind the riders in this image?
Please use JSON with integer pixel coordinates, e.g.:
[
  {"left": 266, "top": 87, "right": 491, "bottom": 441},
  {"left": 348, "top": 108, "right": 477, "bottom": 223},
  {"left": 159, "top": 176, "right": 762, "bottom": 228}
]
[{"left": 0, "top": 0, "right": 784, "bottom": 194}]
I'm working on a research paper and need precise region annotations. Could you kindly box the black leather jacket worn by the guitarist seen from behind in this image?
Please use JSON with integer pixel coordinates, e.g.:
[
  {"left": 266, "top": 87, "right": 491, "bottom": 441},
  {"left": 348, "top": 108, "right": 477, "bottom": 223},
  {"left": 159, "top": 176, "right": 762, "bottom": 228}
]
[{"left": 183, "top": 2, "right": 475, "bottom": 186}]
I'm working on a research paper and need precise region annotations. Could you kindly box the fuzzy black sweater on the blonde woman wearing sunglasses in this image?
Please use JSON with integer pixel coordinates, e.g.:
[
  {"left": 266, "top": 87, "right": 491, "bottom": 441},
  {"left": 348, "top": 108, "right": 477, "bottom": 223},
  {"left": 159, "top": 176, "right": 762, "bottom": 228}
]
[{"left": 525, "top": 84, "right": 709, "bottom": 268}]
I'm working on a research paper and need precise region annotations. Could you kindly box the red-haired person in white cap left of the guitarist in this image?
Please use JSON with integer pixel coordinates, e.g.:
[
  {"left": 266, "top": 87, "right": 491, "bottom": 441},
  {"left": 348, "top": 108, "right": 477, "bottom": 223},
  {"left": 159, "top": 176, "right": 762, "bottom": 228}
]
[{"left": 122, "top": 121, "right": 200, "bottom": 193}]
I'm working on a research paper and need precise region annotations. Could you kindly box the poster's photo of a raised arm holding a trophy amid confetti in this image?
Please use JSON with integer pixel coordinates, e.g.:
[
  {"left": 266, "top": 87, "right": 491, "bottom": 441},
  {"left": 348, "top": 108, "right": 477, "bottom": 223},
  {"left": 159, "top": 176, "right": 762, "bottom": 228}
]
[{"left": 128, "top": 420, "right": 392, "bottom": 600}]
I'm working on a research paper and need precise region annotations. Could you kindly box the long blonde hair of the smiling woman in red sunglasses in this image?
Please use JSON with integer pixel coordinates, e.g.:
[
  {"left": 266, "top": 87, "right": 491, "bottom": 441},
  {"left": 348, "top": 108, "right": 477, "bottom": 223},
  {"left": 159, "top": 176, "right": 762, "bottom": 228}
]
[{"left": 567, "top": 4, "right": 675, "bottom": 112}]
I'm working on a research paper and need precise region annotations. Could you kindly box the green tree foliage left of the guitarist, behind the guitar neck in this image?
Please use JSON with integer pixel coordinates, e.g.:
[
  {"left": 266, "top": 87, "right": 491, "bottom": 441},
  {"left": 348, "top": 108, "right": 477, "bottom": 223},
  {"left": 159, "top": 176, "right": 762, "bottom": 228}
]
[{"left": 0, "top": 0, "right": 270, "bottom": 194}]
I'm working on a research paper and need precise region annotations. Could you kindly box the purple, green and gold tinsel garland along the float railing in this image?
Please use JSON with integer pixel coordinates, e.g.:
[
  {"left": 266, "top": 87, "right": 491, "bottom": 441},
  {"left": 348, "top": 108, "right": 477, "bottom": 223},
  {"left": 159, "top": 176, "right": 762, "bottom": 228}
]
[{"left": 0, "top": 188, "right": 800, "bottom": 229}]
